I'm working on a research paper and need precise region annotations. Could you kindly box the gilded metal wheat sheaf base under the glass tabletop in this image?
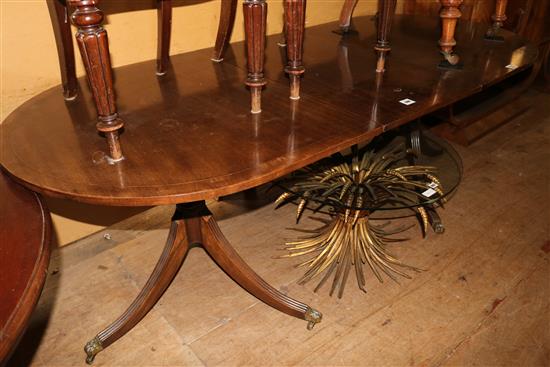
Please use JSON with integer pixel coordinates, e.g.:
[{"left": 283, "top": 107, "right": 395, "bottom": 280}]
[{"left": 275, "top": 144, "right": 443, "bottom": 297}]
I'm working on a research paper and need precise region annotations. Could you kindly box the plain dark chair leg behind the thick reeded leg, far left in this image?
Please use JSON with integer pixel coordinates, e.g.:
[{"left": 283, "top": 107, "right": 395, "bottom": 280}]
[{"left": 46, "top": 0, "right": 78, "bottom": 101}]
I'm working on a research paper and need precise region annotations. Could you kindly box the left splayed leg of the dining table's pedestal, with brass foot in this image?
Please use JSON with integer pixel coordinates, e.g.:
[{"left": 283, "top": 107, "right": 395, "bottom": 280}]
[{"left": 84, "top": 219, "right": 190, "bottom": 364}]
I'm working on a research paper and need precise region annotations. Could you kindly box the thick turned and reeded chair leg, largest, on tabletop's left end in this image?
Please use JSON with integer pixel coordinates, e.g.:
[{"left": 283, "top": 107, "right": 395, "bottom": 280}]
[{"left": 68, "top": 0, "right": 124, "bottom": 161}]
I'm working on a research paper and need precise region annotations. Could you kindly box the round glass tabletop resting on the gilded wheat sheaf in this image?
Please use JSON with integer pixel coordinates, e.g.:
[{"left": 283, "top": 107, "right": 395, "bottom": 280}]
[{"left": 276, "top": 127, "right": 463, "bottom": 214}]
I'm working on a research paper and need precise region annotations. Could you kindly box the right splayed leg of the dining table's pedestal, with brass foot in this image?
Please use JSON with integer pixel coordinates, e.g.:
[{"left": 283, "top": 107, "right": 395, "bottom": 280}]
[{"left": 201, "top": 215, "right": 322, "bottom": 330}]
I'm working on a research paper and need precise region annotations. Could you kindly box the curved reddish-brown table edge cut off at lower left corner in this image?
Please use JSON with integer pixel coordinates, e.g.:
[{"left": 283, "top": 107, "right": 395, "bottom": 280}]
[{"left": 0, "top": 170, "right": 51, "bottom": 366}]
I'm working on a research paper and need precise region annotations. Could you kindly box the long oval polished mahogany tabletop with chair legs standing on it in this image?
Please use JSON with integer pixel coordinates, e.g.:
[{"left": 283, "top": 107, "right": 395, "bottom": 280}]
[{"left": 1, "top": 16, "right": 537, "bottom": 206}]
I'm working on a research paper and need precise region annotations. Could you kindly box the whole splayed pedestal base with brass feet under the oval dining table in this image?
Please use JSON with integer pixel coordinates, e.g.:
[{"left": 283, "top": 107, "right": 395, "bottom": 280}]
[{"left": 84, "top": 201, "right": 322, "bottom": 364}]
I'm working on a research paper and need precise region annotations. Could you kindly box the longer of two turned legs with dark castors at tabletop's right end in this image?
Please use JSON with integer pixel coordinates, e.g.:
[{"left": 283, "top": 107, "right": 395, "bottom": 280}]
[{"left": 439, "top": 0, "right": 463, "bottom": 69}]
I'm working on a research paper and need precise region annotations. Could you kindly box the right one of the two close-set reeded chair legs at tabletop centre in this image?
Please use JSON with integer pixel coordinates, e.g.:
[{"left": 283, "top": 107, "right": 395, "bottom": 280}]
[{"left": 284, "top": 0, "right": 306, "bottom": 99}]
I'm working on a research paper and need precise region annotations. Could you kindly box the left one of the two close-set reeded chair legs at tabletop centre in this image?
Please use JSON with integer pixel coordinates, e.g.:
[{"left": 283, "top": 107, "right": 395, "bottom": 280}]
[{"left": 243, "top": 0, "right": 267, "bottom": 113}]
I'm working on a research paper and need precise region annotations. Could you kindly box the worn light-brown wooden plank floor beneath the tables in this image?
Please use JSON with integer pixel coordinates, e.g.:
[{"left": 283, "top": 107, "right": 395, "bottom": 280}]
[{"left": 6, "top": 91, "right": 550, "bottom": 366}]
